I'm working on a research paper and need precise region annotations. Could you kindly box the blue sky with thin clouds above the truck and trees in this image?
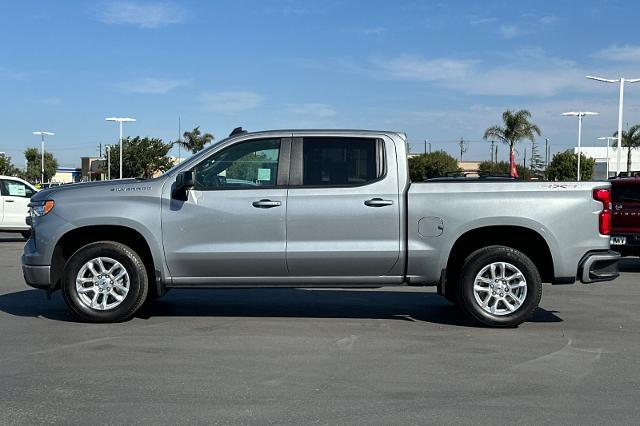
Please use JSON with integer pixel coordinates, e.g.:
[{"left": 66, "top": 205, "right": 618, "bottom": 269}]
[{"left": 0, "top": 0, "right": 640, "bottom": 166}]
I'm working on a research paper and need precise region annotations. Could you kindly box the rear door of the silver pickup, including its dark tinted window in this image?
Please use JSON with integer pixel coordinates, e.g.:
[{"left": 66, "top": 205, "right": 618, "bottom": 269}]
[{"left": 287, "top": 135, "right": 400, "bottom": 282}]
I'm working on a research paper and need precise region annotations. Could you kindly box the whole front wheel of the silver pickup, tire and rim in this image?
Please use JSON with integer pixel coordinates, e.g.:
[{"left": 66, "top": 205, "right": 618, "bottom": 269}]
[{"left": 62, "top": 241, "right": 149, "bottom": 322}]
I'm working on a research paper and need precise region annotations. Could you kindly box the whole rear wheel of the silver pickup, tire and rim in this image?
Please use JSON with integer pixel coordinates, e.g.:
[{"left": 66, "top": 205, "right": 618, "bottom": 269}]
[{"left": 457, "top": 246, "right": 542, "bottom": 327}]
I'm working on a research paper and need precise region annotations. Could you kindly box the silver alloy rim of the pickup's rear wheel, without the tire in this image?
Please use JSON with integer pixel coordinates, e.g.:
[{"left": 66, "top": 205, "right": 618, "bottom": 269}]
[{"left": 473, "top": 262, "right": 527, "bottom": 316}]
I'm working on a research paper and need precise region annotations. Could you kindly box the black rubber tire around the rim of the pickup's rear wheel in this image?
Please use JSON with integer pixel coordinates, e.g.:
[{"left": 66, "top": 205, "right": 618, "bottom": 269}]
[{"left": 457, "top": 246, "right": 542, "bottom": 327}]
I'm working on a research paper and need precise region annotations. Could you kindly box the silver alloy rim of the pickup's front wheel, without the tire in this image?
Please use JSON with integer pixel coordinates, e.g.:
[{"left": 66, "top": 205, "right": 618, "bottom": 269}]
[{"left": 76, "top": 257, "right": 130, "bottom": 311}]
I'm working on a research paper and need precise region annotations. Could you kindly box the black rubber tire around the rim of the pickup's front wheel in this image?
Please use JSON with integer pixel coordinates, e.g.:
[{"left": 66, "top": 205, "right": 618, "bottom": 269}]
[{"left": 62, "top": 241, "right": 149, "bottom": 322}]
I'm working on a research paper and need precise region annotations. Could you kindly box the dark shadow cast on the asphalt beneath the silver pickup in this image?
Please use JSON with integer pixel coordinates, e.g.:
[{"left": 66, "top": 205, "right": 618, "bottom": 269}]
[{"left": 0, "top": 289, "right": 562, "bottom": 327}]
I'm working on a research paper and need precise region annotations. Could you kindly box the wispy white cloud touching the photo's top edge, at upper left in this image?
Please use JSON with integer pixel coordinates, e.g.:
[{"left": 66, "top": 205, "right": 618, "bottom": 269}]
[{"left": 98, "top": 1, "right": 187, "bottom": 28}]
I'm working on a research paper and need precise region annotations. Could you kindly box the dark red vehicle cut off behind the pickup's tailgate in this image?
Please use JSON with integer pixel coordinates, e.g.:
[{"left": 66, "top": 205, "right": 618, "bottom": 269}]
[{"left": 611, "top": 177, "right": 640, "bottom": 256}]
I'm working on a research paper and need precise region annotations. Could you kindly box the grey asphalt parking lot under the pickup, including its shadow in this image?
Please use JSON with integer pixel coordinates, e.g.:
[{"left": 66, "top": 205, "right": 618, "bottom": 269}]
[{"left": 0, "top": 234, "right": 640, "bottom": 424}]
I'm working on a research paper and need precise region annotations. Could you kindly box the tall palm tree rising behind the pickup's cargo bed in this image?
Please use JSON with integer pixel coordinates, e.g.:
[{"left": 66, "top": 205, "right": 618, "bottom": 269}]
[{"left": 483, "top": 109, "right": 541, "bottom": 177}]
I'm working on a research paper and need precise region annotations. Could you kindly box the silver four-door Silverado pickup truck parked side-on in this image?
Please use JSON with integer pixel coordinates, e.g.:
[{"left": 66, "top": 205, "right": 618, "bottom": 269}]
[{"left": 22, "top": 130, "right": 619, "bottom": 327}]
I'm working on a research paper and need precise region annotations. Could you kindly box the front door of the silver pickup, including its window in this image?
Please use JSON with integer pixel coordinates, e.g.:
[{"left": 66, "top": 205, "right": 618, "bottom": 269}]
[{"left": 162, "top": 139, "right": 290, "bottom": 285}]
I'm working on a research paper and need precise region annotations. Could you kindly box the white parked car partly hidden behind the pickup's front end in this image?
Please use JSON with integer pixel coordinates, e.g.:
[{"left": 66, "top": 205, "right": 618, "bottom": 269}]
[{"left": 0, "top": 176, "right": 37, "bottom": 238}]
